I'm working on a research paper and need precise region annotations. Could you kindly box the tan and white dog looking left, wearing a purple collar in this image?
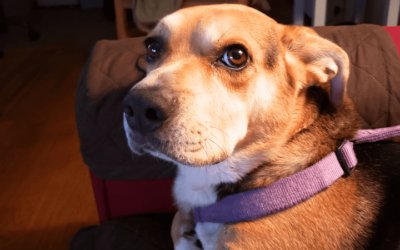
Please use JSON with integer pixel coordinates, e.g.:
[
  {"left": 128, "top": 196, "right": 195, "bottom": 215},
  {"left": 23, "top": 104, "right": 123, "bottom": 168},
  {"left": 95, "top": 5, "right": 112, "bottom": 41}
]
[{"left": 124, "top": 5, "right": 390, "bottom": 249}]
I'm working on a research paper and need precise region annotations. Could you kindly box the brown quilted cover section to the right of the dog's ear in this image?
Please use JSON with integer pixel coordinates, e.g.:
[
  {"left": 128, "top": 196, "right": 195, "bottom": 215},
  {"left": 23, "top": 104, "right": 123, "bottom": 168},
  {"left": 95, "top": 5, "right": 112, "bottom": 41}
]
[{"left": 314, "top": 24, "right": 400, "bottom": 129}]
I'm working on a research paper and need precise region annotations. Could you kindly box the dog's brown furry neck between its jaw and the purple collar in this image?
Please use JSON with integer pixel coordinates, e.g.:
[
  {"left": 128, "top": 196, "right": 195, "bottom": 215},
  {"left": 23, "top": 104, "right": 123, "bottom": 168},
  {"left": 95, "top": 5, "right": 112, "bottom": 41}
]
[{"left": 217, "top": 88, "right": 359, "bottom": 200}]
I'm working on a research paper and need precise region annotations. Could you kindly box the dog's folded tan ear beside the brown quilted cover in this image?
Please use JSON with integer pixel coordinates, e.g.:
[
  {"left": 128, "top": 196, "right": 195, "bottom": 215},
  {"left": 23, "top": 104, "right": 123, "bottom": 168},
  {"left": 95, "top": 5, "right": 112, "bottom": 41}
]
[{"left": 281, "top": 26, "right": 349, "bottom": 107}]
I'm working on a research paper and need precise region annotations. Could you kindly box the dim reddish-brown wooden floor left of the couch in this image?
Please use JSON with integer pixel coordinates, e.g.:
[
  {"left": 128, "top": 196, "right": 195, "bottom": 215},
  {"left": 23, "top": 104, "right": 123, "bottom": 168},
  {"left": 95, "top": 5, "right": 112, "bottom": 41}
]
[{"left": 0, "top": 44, "right": 98, "bottom": 250}]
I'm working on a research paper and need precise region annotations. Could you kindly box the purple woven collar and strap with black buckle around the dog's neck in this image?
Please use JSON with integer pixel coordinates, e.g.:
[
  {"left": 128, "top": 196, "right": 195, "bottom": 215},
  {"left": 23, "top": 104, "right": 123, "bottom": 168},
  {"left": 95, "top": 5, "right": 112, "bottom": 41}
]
[{"left": 194, "top": 126, "right": 400, "bottom": 223}]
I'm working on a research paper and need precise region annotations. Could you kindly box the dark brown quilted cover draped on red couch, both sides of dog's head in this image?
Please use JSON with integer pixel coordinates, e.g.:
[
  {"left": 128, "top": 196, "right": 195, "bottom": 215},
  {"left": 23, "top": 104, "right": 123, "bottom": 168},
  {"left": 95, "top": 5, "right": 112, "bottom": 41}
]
[{"left": 76, "top": 25, "right": 400, "bottom": 180}]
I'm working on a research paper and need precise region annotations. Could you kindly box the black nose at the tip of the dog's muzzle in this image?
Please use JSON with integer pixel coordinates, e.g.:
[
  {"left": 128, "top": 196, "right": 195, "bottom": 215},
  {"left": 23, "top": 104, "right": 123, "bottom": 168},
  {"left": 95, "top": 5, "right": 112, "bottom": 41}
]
[{"left": 124, "top": 92, "right": 168, "bottom": 134}]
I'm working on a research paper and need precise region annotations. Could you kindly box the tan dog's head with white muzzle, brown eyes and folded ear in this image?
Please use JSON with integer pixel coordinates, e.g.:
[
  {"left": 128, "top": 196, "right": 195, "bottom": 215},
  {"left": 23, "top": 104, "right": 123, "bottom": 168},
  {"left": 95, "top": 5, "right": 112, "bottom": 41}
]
[{"left": 124, "top": 5, "right": 349, "bottom": 171}]
